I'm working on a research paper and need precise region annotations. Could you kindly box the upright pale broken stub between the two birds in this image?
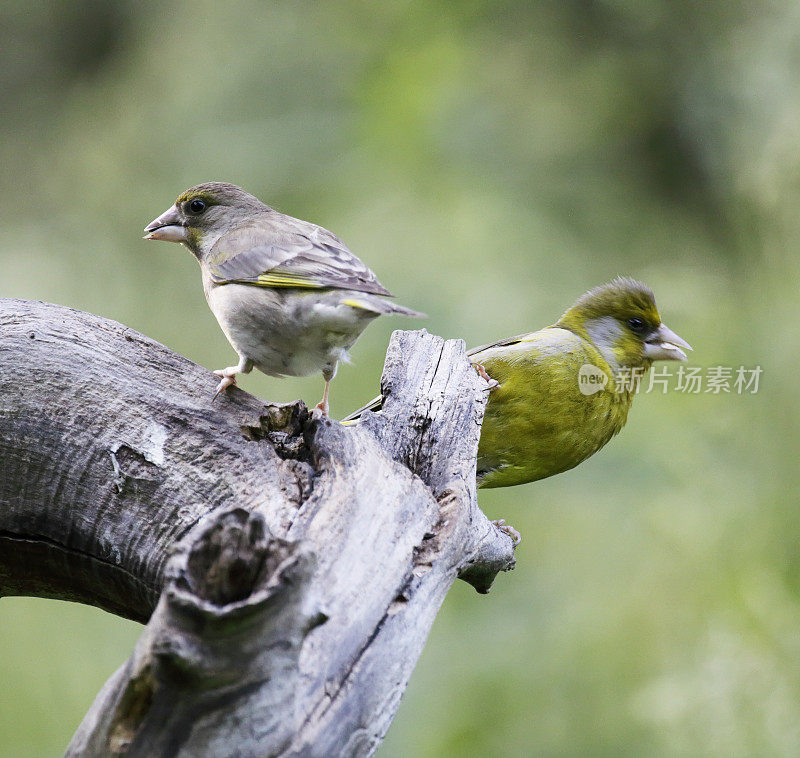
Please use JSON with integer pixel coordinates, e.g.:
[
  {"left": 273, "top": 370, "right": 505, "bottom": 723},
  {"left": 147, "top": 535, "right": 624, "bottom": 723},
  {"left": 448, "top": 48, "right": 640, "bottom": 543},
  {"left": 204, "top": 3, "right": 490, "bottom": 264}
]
[{"left": 361, "top": 329, "right": 515, "bottom": 592}]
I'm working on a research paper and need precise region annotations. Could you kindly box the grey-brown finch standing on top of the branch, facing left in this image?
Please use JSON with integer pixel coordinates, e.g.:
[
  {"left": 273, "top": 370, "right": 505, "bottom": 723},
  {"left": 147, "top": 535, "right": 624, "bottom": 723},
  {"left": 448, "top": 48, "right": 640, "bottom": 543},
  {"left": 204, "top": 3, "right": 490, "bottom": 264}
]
[{"left": 144, "top": 182, "right": 424, "bottom": 415}]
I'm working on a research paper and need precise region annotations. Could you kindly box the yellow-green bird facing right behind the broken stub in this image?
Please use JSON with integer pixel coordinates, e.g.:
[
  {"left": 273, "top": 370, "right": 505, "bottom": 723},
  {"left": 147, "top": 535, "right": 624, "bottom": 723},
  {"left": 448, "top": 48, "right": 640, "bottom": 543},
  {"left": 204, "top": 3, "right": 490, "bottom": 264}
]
[{"left": 346, "top": 278, "right": 691, "bottom": 487}]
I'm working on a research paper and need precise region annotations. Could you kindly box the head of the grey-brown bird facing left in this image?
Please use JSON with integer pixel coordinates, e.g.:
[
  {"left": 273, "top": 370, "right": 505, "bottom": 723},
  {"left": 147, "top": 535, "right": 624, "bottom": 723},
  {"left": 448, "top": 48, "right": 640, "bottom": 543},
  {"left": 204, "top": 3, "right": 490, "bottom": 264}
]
[{"left": 144, "top": 182, "right": 271, "bottom": 257}]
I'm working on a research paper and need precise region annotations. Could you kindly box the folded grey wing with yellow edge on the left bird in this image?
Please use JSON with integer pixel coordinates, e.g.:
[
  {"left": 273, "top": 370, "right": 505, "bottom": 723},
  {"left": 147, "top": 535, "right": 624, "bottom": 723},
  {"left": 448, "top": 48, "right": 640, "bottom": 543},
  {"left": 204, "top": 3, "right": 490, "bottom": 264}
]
[{"left": 205, "top": 216, "right": 391, "bottom": 296}]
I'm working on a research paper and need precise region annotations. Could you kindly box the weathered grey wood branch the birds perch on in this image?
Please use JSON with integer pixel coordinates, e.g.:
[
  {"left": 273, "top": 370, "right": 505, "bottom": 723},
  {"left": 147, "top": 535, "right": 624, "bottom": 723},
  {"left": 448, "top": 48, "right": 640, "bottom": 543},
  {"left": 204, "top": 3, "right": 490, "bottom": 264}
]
[{"left": 0, "top": 300, "right": 514, "bottom": 756}]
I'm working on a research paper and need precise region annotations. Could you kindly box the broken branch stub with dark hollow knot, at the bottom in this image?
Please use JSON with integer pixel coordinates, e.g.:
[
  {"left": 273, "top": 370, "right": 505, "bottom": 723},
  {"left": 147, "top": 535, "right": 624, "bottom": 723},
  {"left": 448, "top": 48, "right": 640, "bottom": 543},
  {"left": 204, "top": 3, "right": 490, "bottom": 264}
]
[{"left": 67, "top": 509, "right": 318, "bottom": 756}]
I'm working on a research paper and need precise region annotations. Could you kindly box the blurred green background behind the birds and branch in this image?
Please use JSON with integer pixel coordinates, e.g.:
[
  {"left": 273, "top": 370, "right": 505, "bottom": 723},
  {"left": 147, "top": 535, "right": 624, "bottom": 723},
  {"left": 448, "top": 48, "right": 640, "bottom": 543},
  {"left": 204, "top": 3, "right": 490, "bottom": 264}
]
[{"left": 0, "top": 0, "right": 800, "bottom": 758}]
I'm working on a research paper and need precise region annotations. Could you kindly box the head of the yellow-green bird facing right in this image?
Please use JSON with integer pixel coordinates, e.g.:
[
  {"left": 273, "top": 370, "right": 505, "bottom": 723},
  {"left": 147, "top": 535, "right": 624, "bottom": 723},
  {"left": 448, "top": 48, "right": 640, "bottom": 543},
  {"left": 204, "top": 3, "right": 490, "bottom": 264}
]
[{"left": 557, "top": 277, "right": 692, "bottom": 369}]
